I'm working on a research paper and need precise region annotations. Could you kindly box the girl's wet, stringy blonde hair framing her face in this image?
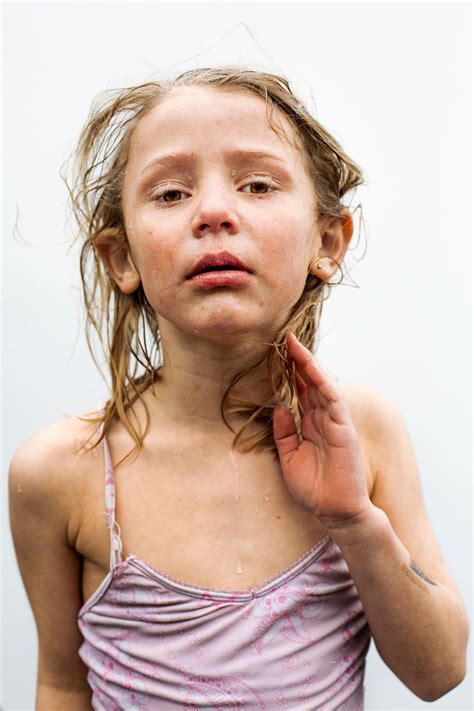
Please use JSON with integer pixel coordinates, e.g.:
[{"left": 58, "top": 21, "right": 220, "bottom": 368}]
[{"left": 62, "top": 66, "right": 363, "bottom": 466}]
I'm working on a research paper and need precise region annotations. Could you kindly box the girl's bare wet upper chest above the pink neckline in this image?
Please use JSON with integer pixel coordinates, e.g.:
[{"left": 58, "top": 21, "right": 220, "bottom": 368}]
[{"left": 76, "top": 437, "right": 370, "bottom": 600}]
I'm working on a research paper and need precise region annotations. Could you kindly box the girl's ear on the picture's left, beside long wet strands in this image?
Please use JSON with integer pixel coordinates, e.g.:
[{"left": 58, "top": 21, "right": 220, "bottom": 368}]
[{"left": 94, "top": 227, "right": 141, "bottom": 294}]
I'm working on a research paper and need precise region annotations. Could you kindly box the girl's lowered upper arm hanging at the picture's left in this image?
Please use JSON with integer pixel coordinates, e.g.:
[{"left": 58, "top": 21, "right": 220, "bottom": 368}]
[{"left": 8, "top": 425, "right": 91, "bottom": 690}]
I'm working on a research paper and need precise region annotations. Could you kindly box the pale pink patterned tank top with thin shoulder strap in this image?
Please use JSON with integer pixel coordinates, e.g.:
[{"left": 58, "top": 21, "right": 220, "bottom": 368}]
[{"left": 77, "top": 426, "right": 371, "bottom": 711}]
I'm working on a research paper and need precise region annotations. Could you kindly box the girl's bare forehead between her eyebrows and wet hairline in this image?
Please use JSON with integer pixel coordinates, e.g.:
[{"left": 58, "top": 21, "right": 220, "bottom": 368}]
[{"left": 129, "top": 86, "right": 301, "bottom": 168}]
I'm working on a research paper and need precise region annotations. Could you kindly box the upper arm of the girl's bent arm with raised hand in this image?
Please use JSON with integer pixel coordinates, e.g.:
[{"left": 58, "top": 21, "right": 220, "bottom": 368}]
[{"left": 344, "top": 387, "right": 461, "bottom": 601}]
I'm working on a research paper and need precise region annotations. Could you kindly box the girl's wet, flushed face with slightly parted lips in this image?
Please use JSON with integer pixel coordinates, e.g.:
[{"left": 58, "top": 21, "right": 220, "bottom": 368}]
[{"left": 122, "top": 86, "right": 320, "bottom": 338}]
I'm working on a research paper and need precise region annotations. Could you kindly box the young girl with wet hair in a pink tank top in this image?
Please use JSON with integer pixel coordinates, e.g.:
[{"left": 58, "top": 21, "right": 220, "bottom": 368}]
[{"left": 9, "top": 67, "right": 468, "bottom": 711}]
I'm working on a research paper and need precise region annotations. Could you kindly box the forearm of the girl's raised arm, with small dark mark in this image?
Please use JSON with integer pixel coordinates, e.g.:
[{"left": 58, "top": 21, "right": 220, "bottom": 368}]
[{"left": 331, "top": 506, "right": 469, "bottom": 701}]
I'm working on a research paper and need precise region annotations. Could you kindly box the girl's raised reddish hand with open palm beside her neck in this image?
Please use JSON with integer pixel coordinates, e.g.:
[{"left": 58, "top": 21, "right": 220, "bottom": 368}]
[{"left": 273, "top": 333, "right": 372, "bottom": 530}]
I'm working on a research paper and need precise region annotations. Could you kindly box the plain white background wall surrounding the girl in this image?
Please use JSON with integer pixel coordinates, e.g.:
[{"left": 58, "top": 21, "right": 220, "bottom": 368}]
[{"left": 1, "top": 2, "right": 472, "bottom": 711}]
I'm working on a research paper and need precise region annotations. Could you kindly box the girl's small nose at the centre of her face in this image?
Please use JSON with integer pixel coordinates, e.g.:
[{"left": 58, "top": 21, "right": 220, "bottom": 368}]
[{"left": 191, "top": 180, "right": 239, "bottom": 237}]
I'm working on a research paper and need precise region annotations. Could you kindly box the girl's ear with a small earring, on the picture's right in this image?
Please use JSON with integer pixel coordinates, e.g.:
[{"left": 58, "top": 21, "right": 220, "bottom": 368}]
[{"left": 310, "top": 207, "right": 354, "bottom": 281}]
